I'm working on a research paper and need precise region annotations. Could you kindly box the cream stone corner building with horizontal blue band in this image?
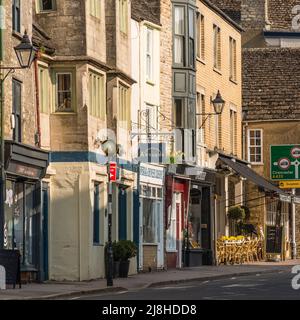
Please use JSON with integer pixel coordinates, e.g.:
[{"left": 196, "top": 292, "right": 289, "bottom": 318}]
[{"left": 32, "top": 0, "right": 136, "bottom": 281}]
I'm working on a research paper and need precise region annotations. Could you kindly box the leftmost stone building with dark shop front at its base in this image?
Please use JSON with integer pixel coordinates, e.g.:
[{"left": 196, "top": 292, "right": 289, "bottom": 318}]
[{"left": 0, "top": 1, "right": 49, "bottom": 279}]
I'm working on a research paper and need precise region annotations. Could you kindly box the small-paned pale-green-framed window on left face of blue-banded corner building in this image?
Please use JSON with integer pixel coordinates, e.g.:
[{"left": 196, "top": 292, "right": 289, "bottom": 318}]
[{"left": 55, "top": 72, "right": 74, "bottom": 112}]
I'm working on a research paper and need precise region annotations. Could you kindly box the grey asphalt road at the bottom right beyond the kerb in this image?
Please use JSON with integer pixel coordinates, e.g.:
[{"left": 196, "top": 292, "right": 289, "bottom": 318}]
[{"left": 72, "top": 271, "right": 300, "bottom": 301}]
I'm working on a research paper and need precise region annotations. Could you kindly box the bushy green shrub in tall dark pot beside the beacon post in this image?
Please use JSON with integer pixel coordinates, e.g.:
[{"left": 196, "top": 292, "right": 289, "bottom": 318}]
[{"left": 116, "top": 240, "right": 137, "bottom": 278}]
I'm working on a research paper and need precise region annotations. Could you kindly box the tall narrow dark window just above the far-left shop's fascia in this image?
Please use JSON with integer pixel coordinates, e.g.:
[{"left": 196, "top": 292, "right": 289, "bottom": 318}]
[{"left": 12, "top": 79, "right": 22, "bottom": 142}]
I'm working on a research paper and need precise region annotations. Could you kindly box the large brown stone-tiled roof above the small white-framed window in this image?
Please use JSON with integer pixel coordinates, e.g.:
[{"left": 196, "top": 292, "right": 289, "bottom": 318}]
[{"left": 243, "top": 48, "right": 300, "bottom": 121}]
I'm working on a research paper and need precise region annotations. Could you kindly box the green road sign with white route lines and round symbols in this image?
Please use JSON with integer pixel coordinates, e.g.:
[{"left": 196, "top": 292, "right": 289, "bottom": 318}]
[{"left": 270, "top": 145, "right": 300, "bottom": 181}]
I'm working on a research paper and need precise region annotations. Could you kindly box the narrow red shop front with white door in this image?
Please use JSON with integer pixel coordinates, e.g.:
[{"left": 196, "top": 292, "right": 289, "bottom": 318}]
[{"left": 165, "top": 175, "right": 190, "bottom": 268}]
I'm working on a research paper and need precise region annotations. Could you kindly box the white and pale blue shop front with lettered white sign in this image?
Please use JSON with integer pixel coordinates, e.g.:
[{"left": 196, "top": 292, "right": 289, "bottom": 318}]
[{"left": 139, "top": 164, "right": 164, "bottom": 271}]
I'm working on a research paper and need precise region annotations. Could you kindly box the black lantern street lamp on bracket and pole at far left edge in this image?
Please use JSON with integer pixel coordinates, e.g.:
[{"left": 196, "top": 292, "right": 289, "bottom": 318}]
[{"left": 0, "top": 30, "right": 38, "bottom": 249}]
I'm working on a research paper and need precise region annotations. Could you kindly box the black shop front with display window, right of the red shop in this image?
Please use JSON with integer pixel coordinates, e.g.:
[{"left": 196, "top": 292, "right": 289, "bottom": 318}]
[{"left": 184, "top": 170, "right": 215, "bottom": 267}]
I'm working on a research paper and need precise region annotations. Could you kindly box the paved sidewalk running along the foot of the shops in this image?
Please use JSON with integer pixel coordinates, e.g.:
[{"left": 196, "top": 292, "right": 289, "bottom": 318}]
[{"left": 0, "top": 260, "right": 300, "bottom": 300}]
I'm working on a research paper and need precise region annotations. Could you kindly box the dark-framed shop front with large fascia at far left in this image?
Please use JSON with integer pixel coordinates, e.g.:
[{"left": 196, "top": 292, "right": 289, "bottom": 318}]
[{"left": 3, "top": 141, "right": 49, "bottom": 280}]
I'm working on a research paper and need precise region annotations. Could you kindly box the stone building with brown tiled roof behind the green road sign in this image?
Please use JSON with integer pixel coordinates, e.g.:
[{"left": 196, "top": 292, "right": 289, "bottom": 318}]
[{"left": 213, "top": 0, "right": 300, "bottom": 258}]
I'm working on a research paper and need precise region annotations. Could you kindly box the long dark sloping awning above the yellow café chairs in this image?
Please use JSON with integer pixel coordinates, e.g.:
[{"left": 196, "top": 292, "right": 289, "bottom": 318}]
[{"left": 219, "top": 155, "right": 285, "bottom": 194}]
